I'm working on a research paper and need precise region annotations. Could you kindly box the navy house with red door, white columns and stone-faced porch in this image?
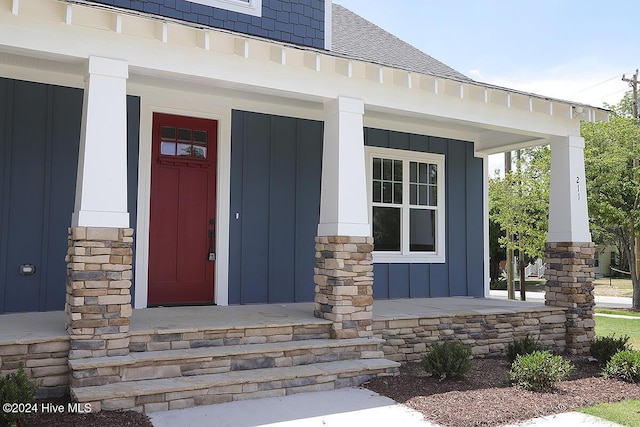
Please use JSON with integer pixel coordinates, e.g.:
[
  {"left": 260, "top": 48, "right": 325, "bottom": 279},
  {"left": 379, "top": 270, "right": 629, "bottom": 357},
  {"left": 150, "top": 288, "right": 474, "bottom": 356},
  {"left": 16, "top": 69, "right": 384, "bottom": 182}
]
[{"left": 0, "top": 0, "right": 607, "bottom": 411}]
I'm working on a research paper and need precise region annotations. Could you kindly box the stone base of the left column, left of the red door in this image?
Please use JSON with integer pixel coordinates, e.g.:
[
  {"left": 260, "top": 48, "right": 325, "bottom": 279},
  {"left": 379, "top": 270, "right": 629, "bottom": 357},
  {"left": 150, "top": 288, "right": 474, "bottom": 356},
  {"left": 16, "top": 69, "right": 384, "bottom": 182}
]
[{"left": 65, "top": 227, "right": 133, "bottom": 359}]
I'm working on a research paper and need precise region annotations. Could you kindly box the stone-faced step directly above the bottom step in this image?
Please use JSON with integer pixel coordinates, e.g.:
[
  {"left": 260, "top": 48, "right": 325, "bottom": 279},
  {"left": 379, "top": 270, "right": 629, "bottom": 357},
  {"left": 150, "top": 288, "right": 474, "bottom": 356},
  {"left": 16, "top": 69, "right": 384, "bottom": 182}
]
[{"left": 69, "top": 338, "right": 384, "bottom": 387}]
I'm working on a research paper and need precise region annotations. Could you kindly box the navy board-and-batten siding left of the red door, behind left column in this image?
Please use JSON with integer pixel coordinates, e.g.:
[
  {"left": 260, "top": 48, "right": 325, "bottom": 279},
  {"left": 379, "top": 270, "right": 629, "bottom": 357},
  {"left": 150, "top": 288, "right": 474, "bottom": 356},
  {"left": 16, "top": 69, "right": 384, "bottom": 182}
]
[{"left": 0, "top": 78, "right": 140, "bottom": 313}]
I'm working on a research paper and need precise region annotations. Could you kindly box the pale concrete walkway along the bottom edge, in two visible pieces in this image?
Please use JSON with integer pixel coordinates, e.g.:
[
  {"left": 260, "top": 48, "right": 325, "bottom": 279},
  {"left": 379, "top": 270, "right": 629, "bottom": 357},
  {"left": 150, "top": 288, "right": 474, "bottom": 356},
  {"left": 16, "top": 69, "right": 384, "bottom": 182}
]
[{"left": 149, "top": 388, "right": 619, "bottom": 427}]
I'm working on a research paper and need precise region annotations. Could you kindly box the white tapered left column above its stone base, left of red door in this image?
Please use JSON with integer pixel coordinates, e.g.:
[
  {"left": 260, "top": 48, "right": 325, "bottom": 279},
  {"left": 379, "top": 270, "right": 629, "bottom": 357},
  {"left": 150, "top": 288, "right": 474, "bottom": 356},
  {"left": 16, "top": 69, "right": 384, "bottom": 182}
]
[{"left": 71, "top": 56, "right": 129, "bottom": 228}]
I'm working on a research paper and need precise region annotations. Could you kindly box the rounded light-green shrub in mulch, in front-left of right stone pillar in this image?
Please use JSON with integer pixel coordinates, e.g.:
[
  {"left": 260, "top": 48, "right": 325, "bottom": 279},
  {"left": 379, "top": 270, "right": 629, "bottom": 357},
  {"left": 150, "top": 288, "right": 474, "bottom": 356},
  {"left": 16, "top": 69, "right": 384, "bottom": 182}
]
[{"left": 509, "top": 350, "right": 573, "bottom": 391}]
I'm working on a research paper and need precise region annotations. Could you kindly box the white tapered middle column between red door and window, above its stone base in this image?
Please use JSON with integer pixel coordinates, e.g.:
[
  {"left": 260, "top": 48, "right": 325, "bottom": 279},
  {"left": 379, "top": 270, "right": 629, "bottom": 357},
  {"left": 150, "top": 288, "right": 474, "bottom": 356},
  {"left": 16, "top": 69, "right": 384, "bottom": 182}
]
[{"left": 318, "top": 97, "right": 371, "bottom": 236}]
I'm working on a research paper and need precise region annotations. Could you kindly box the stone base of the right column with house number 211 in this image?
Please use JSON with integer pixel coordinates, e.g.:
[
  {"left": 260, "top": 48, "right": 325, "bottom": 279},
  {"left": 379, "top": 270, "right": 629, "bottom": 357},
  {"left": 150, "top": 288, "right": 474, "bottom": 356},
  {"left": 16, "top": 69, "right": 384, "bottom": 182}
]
[{"left": 545, "top": 242, "right": 595, "bottom": 355}]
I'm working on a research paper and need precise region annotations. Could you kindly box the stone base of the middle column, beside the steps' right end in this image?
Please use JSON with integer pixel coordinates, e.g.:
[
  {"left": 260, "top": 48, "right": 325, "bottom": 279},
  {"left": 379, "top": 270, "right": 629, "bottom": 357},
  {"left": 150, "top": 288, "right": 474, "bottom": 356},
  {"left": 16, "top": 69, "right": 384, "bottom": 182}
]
[{"left": 313, "top": 236, "right": 373, "bottom": 339}]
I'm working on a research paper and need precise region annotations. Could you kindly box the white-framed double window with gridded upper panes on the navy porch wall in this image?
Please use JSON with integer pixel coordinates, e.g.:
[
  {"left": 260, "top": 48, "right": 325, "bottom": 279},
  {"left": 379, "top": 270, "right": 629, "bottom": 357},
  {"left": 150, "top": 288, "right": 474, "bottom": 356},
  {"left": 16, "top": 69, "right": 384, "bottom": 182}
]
[{"left": 366, "top": 147, "right": 445, "bottom": 263}]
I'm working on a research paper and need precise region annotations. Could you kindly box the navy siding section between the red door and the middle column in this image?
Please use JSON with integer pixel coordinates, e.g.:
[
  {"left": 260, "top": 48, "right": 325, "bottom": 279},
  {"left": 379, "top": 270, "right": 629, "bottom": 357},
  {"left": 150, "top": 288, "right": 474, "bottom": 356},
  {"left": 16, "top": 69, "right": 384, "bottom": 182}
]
[{"left": 229, "top": 111, "right": 323, "bottom": 304}]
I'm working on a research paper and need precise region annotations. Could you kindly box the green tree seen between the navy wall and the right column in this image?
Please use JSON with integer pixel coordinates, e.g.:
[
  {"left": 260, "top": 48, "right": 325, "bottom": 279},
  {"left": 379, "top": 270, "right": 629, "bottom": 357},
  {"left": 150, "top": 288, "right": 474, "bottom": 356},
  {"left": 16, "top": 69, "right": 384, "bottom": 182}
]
[{"left": 489, "top": 146, "right": 551, "bottom": 285}]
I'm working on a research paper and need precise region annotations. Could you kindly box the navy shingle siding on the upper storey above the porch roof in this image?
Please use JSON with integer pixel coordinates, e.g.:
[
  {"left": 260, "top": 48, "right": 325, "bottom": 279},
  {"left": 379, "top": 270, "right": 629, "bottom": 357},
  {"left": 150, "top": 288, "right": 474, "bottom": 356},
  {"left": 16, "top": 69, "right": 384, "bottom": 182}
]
[{"left": 85, "top": 0, "right": 325, "bottom": 49}]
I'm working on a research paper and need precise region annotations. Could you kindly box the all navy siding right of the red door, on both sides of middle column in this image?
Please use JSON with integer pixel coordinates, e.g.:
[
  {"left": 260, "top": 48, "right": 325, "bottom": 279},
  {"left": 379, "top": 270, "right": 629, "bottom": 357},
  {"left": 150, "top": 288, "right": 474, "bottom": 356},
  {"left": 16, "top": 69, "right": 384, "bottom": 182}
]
[{"left": 229, "top": 111, "right": 484, "bottom": 304}]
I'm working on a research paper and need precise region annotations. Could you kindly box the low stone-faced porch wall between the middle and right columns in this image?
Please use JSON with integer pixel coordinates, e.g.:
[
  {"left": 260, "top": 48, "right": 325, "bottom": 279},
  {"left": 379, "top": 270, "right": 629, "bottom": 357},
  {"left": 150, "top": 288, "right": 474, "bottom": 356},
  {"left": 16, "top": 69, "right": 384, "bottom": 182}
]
[{"left": 373, "top": 306, "right": 566, "bottom": 363}]
